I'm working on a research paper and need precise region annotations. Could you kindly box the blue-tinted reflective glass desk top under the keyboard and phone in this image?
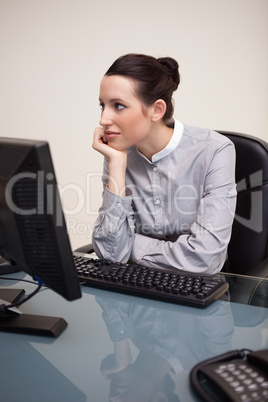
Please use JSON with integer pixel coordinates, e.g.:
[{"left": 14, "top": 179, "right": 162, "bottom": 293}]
[{"left": 0, "top": 273, "right": 268, "bottom": 402}]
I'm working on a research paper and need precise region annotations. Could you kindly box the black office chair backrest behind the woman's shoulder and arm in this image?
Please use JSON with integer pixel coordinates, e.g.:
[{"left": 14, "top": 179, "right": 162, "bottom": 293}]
[{"left": 217, "top": 130, "right": 268, "bottom": 274}]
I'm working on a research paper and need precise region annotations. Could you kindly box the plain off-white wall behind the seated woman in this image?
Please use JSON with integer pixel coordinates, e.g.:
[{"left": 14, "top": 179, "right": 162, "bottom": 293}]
[{"left": 0, "top": 0, "right": 268, "bottom": 248}]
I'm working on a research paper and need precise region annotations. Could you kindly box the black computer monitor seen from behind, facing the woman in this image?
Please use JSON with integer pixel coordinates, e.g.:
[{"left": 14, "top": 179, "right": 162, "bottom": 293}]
[{"left": 0, "top": 137, "right": 81, "bottom": 336}]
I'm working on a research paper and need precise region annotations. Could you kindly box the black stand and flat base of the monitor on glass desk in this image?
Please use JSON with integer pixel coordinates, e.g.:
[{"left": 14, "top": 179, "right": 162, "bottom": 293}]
[{"left": 0, "top": 289, "right": 68, "bottom": 337}]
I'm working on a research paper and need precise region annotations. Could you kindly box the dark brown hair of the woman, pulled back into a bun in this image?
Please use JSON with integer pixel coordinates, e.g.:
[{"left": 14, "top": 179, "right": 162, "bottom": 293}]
[{"left": 105, "top": 53, "right": 180, "bottom": 121}]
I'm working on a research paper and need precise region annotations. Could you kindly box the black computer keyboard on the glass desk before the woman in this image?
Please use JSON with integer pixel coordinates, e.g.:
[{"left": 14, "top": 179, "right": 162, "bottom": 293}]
[{"left": 74, "top": 253, "right": 229, "bottom": 308}]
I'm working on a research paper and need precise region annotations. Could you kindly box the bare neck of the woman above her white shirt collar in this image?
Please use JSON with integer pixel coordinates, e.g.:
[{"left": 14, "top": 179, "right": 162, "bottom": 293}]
[{"left": 136, "top": 122, "right": 174, "bottom": 161}]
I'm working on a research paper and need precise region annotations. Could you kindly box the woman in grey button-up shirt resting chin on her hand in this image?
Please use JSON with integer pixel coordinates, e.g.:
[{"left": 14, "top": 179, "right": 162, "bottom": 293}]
[{"left": 93, "top": 54, "right": 236, "bottom": 274}]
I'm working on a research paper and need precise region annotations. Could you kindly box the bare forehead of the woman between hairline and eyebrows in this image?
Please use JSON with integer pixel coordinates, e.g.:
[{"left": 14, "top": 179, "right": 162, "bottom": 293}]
[{"left": 100, "top": 75, "right": 137, "bottom": 101}]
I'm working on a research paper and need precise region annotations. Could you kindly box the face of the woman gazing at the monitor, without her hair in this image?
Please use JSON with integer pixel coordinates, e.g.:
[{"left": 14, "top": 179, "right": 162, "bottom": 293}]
[{"left": 100, "top": 75, "right": 152, "bottom": 151}]
